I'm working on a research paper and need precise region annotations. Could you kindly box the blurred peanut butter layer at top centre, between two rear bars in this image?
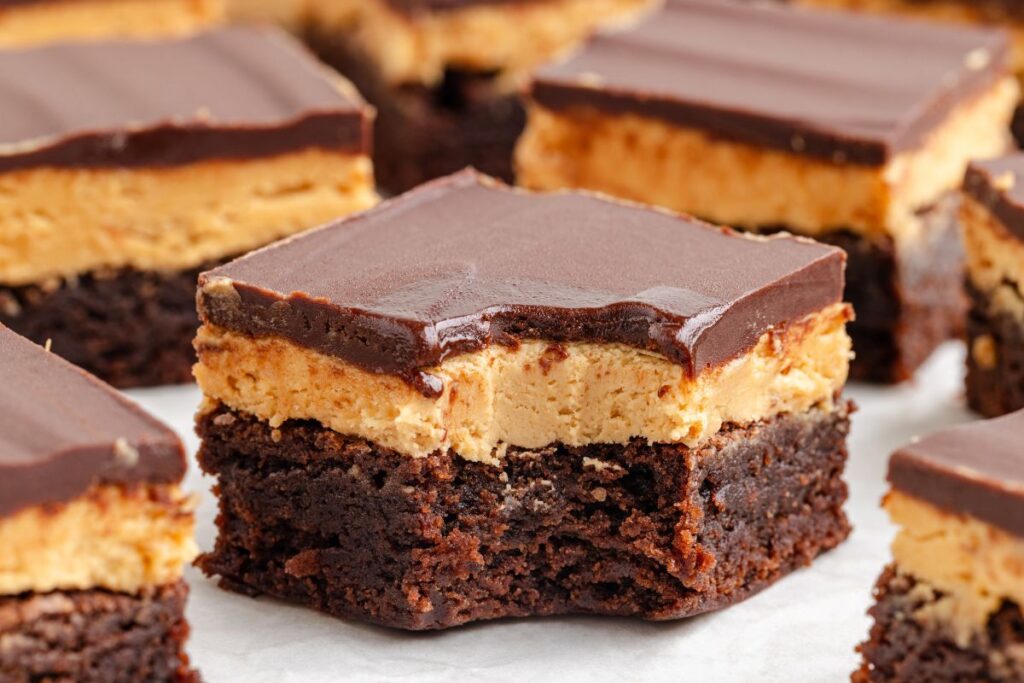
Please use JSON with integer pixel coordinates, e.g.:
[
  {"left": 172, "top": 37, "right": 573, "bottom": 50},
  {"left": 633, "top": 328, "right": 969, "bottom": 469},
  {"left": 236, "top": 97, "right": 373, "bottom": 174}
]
[{"left": 303, "top": 0, "right": 658, "bottom": 85}]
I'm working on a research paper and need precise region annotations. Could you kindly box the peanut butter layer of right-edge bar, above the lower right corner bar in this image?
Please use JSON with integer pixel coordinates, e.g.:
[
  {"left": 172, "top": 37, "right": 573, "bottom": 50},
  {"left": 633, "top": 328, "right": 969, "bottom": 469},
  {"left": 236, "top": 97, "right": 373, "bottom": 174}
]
[{"left": 961, "top": 192, "right": 1024, "bottom": 323}]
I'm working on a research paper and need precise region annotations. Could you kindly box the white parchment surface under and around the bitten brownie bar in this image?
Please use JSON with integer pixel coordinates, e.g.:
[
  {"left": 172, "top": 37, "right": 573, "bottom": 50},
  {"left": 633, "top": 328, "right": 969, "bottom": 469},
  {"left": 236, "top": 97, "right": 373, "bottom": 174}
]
[{"left": 130, "top": 344, "right": 972, "bottom": 683}]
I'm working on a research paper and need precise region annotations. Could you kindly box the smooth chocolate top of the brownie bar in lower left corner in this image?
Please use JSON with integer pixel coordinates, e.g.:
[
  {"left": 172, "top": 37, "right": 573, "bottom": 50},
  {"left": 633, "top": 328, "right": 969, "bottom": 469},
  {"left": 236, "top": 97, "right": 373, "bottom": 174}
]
[{"left": 0, "top": 326, "right": 185, "bottom": 515}]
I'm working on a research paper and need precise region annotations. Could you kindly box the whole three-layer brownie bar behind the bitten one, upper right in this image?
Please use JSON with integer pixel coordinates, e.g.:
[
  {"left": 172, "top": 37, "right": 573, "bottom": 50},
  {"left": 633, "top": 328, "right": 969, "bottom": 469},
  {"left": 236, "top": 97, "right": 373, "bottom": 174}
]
[{"left": 517, "top": 0, "right": 1018, "bottom": 382}]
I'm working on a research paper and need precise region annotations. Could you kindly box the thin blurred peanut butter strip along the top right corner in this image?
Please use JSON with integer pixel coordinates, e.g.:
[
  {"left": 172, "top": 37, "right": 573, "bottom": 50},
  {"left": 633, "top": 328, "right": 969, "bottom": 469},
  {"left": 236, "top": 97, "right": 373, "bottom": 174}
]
[{"left": 796, "top": 0, "right": 1024, "bottom": 75}]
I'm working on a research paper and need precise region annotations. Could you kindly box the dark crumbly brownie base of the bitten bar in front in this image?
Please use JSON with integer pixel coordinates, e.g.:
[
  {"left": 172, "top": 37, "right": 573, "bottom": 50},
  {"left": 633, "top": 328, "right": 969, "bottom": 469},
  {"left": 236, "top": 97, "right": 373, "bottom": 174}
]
[{"left": 198, "top": 408, "right": 850, "bottom": 630}]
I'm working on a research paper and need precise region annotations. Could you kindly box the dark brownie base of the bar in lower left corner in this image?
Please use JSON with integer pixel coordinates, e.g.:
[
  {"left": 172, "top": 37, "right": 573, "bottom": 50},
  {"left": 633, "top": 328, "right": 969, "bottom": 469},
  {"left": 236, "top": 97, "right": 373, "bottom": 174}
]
[{"left": 0, "top": 582, "right": 200, "bottom": 683}]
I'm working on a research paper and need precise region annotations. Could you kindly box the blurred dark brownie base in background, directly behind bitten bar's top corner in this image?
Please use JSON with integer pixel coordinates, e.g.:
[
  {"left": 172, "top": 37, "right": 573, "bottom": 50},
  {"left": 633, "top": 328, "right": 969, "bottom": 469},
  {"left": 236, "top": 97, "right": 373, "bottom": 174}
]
[{"left": 304, "top": 28, "right": 526, "bottom": 195}]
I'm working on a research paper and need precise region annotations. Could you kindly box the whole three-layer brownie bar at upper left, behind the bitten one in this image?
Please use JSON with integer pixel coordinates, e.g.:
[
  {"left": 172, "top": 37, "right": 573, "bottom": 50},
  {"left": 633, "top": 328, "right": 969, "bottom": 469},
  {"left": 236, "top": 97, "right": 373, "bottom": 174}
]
[{"left": 0, "top": 29, "right": 377, "bottom": 387}]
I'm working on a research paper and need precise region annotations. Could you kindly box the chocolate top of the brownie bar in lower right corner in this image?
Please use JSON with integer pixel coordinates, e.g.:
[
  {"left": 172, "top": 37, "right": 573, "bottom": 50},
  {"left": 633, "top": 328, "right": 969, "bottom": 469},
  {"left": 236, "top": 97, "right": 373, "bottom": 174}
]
[{"left": 889, "top": 412, "right": 1024, "bottom": 537}]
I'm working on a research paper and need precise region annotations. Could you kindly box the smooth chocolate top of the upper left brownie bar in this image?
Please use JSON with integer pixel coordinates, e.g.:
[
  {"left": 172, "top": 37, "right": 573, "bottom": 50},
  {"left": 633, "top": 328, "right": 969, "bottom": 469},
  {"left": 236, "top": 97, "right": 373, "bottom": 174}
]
[{"left": 0, "top": 28, "right": 369, "bottom": 171}]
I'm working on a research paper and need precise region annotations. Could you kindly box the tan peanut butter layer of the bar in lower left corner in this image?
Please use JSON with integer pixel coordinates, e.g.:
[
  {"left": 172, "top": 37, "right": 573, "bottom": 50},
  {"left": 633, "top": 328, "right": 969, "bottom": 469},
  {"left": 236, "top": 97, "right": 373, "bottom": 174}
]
[{"left": 0, "top": 485, "right": 197, "bottom": 595}]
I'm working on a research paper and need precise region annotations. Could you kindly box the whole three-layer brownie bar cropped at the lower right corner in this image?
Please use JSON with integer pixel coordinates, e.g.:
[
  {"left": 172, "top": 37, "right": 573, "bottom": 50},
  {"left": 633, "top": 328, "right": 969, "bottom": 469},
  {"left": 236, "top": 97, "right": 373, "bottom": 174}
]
[{"left": 853, "top": 413, "right": 1024, "bottom": 683}]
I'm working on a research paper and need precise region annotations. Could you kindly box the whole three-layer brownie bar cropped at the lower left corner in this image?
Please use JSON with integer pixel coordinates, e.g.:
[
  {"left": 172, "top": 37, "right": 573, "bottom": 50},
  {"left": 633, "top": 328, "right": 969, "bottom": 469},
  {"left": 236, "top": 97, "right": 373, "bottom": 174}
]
[{"left": 0, "top": 326, "right": 196, "bottom": 683}]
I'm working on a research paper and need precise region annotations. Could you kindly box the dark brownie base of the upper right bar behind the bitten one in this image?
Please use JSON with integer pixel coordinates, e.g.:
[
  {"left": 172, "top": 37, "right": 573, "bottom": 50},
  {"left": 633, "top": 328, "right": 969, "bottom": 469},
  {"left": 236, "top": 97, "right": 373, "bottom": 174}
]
[{"left": 802, "top": 197, "right": 967, "bottom": 384}]
